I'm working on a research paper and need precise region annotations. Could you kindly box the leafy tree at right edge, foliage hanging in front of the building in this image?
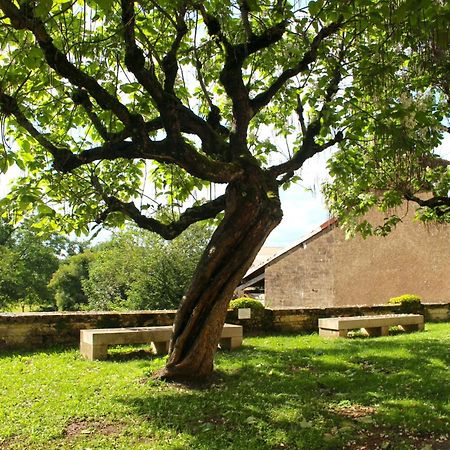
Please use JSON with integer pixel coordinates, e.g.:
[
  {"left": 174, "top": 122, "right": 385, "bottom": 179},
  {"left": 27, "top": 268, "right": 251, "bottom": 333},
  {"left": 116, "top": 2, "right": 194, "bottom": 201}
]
[{"left": 324, "top": 0, "right": 450, "bottom": 235}]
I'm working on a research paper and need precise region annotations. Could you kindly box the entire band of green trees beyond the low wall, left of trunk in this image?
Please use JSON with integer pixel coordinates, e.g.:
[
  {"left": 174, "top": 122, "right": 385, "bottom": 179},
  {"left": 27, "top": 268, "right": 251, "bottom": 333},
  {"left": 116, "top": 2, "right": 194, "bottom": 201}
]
[{"left": 0, "top": 222, "right": 211, "bottom": 311}]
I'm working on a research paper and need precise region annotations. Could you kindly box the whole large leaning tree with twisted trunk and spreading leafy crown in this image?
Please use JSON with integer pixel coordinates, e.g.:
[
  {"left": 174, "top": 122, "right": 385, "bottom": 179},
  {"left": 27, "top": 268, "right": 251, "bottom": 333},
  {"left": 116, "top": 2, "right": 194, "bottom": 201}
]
[{"left": 0, "top": 0, "right": 446, "bottom": 379}]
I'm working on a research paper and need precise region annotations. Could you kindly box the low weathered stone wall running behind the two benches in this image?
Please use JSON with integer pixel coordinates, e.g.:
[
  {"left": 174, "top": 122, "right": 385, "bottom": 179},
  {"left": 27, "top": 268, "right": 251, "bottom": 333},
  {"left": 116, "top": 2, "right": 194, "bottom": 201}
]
[{"left": 0, "top": 303, "right": 450, "bottom": 351}]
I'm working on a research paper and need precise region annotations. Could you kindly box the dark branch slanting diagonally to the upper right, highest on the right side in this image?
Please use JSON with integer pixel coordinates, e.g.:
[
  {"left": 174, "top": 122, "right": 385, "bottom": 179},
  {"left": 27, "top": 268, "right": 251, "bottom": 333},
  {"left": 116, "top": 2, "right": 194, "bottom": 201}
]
[{"left": 250, "top": 18, "right": 343, "bottom": 115}]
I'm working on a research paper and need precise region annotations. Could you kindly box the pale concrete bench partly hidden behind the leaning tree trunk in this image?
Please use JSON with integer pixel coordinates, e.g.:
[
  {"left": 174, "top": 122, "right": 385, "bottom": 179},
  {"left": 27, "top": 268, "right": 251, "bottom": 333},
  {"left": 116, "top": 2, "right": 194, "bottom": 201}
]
[{"left": 80, "top": 323, "right": 242, "bottom": 361}]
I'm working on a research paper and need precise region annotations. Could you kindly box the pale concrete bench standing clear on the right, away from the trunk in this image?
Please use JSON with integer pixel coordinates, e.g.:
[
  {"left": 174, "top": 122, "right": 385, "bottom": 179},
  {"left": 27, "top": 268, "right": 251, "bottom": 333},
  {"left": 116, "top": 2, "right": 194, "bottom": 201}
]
[{"left": 319, "top": 314, "right": 424, "bottom": 338}]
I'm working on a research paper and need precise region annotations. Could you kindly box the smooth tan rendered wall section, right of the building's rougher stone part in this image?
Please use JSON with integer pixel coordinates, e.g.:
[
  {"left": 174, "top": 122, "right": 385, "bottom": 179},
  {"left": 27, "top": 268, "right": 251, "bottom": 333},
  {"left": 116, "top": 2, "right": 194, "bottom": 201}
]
[{"left": 332, "top": 216, "right": 450, "bottom": 306}]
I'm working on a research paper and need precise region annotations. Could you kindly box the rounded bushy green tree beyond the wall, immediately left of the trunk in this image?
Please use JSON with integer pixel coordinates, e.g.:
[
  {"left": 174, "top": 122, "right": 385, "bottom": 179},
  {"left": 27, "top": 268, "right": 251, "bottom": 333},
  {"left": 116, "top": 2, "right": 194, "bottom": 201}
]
[{"left": 82, "top": 225, "right": 211, "bottom": 310}]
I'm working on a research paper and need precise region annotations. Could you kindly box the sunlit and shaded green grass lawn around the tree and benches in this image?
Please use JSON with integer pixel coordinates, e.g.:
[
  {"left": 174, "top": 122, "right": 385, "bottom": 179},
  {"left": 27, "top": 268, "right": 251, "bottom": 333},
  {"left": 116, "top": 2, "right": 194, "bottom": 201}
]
[{"left": 0, "top": 324, "right": 450, "bottom": 450}]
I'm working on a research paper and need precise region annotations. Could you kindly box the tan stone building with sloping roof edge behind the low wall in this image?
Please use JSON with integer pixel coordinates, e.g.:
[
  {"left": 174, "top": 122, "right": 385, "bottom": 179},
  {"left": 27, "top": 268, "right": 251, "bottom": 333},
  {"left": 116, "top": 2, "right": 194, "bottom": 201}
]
[{"left": 238, "top": 206, "right": 450, "bottom": 308}]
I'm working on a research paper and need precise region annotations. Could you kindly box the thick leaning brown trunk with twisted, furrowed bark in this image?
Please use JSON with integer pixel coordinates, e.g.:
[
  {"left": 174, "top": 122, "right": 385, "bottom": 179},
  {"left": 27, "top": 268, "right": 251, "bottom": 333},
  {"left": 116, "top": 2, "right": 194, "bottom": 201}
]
[{"left": 155, "top": 174, "right": 282, "bottom": 380}]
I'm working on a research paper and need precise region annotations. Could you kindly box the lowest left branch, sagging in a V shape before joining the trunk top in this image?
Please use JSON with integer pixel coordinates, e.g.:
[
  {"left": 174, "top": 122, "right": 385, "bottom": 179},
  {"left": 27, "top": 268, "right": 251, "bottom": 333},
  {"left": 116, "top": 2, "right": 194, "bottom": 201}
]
[{"left": 97, "top": 194, "right": 226, "bottom": 240}]
